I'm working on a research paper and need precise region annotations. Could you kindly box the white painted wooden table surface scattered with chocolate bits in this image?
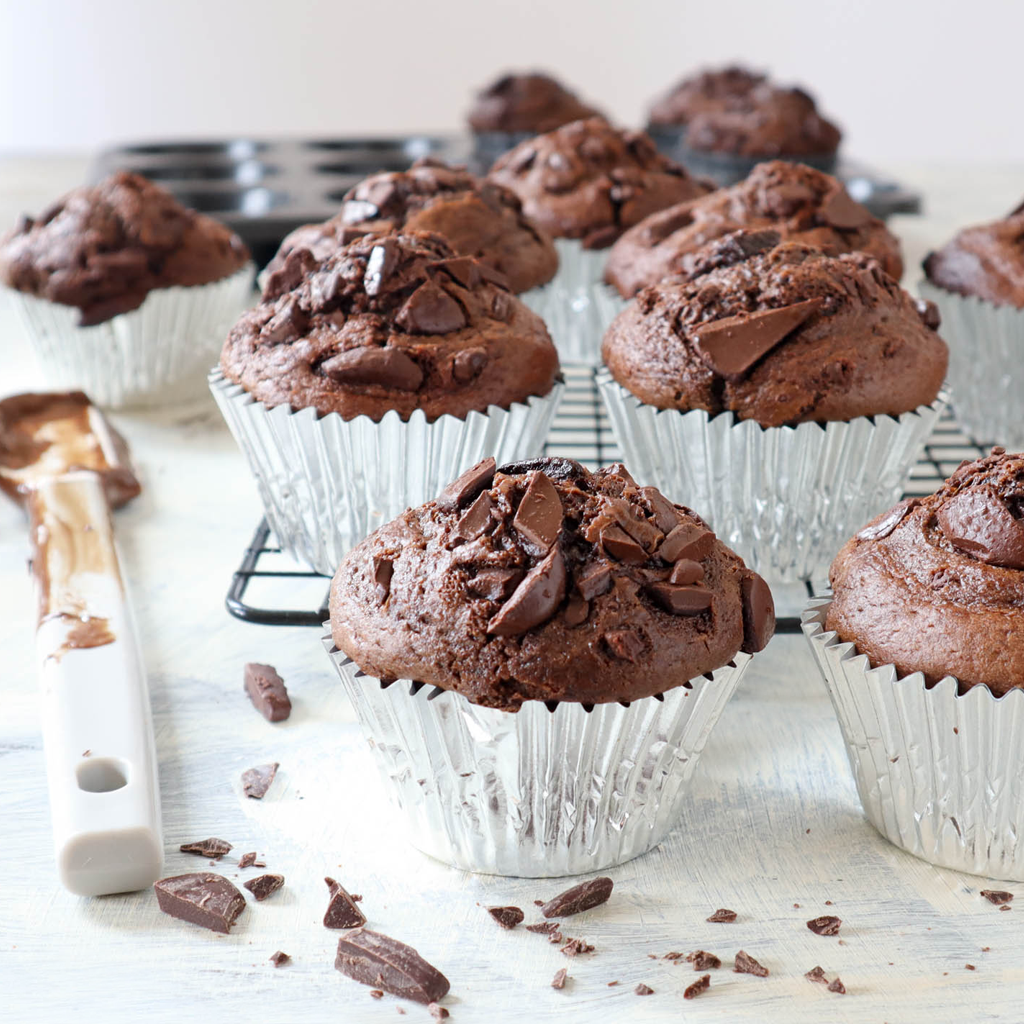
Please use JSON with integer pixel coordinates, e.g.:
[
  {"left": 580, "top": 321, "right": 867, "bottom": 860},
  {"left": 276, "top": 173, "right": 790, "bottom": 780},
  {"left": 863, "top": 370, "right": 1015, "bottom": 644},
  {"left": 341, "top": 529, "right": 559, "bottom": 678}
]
[{"left": 0, "top": 159, "right": 1024, "bottom": 1024}]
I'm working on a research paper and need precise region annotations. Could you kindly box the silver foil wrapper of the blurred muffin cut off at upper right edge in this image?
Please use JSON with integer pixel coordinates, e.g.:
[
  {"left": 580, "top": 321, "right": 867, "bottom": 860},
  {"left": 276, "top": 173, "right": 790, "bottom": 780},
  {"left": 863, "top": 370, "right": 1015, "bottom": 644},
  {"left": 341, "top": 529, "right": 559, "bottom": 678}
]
[{"left": 918, "top": 281, "right": 1024, "bottom": 452}]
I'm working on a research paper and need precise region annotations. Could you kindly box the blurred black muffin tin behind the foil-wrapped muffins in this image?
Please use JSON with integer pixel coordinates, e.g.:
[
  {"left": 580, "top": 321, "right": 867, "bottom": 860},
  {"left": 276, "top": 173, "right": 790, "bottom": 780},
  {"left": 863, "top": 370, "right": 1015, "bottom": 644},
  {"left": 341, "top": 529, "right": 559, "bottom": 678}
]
[{"left": 91, "top": 134, "right": 921, "bottom": 266}]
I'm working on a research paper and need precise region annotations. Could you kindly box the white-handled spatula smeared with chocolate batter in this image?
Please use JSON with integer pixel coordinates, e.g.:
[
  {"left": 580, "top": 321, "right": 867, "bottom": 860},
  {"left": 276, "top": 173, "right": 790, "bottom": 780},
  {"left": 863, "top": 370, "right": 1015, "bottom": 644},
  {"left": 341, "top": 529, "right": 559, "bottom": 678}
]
[{"left": 0, "top": 392, "right": 163, "bottom": 896}]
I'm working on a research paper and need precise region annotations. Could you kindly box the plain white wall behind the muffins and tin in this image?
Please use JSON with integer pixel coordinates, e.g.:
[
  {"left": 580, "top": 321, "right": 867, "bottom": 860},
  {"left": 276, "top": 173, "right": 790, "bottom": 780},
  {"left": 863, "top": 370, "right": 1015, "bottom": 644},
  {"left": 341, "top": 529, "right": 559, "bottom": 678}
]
[{"left": 0, "top": 0, "right": 1024, "bottom": 164}]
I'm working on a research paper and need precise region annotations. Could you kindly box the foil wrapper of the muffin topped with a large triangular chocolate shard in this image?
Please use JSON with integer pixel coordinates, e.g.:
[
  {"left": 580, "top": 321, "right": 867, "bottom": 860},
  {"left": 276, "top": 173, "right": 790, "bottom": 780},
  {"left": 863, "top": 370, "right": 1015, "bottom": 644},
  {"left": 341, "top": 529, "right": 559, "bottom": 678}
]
[{"left": 598, "top": 371, "right": 946, "bottom": 584}]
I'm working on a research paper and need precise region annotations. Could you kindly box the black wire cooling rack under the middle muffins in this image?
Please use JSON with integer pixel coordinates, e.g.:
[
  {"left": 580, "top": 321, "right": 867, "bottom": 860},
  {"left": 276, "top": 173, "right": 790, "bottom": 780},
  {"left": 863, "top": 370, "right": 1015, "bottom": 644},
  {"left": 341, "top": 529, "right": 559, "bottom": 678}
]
[{"left": 226, "top": 366, "right": 984, "bottom": 633}]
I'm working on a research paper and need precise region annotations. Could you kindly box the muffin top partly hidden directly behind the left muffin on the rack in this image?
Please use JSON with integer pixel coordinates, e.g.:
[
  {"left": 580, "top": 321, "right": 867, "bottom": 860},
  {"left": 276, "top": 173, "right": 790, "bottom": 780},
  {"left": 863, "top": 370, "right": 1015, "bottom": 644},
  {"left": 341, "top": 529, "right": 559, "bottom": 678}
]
[{"left": 260, "top": 158, "right": 558, "bottom": 293}]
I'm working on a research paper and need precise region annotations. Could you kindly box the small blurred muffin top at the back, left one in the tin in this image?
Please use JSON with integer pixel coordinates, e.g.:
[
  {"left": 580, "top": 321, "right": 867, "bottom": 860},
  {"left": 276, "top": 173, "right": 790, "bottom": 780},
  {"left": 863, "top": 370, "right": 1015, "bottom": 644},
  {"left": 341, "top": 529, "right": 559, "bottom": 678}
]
[{"left": 467, "top": 72, "right": 601, "bottom": 134}]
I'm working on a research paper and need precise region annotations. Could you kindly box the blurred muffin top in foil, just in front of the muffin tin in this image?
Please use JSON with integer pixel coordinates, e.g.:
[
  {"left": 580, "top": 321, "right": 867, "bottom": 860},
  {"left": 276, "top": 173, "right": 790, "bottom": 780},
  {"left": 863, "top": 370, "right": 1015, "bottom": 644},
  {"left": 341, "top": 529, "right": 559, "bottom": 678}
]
[{"left": 489, "top": 118, "right": 712, "bottom": 249}]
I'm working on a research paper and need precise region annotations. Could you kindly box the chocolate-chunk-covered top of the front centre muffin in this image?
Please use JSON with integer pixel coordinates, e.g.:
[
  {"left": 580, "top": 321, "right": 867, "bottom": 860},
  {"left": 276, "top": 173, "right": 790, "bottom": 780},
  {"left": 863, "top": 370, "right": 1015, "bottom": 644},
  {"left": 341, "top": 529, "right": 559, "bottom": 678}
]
[{"left": 331, "top": 459, "right": 775, "bottom": 711}]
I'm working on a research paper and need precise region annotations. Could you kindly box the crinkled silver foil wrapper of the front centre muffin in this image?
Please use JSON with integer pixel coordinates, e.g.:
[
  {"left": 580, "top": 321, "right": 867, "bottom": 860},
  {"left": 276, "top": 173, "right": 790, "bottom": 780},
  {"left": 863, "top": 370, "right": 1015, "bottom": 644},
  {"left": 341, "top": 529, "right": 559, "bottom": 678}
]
[{"left": 324, "top": 626, "right": 751, "bottom": 878}]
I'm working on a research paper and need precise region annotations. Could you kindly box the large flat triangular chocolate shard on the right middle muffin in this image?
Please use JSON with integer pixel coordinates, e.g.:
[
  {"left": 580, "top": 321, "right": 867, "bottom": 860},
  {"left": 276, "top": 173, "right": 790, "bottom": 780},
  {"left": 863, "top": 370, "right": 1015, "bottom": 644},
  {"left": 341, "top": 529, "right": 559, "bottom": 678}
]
[{"left": 692, "top": 299, "right": 822, "bottom": 381}]
